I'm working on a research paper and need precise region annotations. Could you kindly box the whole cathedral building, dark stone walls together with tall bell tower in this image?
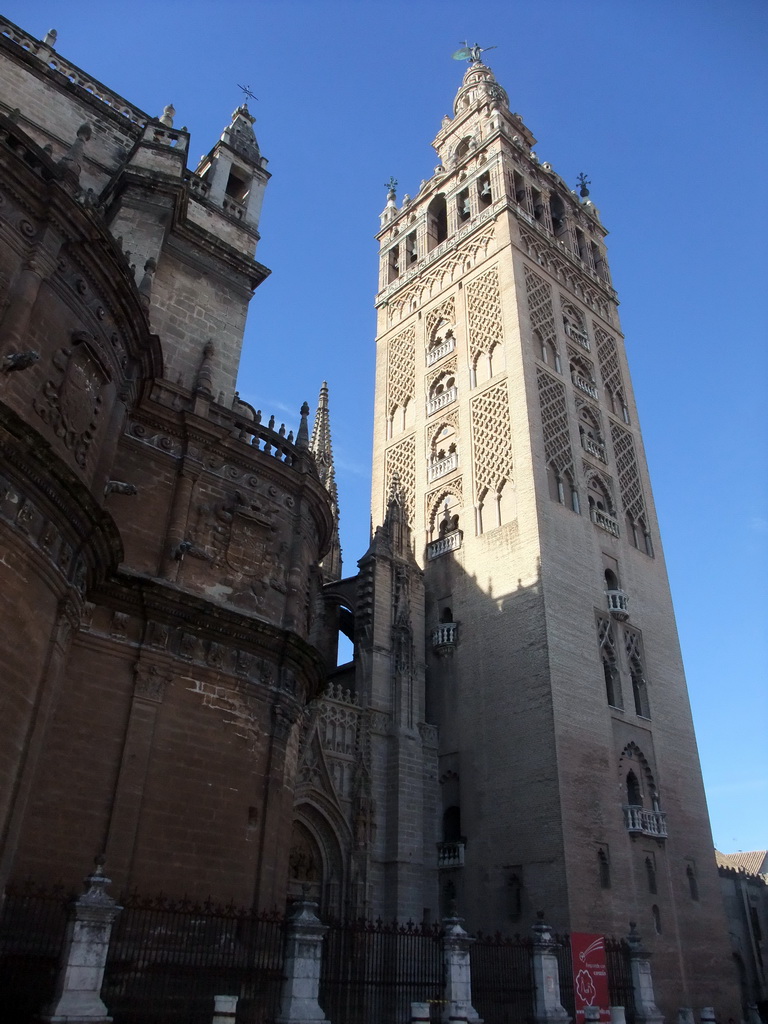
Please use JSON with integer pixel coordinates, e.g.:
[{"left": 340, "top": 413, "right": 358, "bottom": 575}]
[{"left": 0, "top": 23, "right": 734, "bottom": 1016}]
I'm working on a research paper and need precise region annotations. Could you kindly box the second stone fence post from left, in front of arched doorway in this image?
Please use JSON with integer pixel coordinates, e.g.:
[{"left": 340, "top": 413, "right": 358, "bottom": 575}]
[{"left": 275, "top": 892, "right": 330, "bottom": 1024}]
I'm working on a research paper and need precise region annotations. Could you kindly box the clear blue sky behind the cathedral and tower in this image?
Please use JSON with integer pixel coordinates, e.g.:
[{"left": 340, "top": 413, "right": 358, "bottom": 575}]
[{"left": 4, "top": 0, "right": 768, "bottom": 851}]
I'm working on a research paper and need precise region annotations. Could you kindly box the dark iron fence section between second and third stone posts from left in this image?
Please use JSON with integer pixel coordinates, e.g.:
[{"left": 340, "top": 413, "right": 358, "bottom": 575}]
[{"left": 318, "top": 921, "right": 444, "bottom": 1024}]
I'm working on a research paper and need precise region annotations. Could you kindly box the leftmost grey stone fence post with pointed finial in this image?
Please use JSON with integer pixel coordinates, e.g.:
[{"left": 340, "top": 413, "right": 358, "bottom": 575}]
[{"left": 39, "top": 860, "right": 123, "bottom": 1024}]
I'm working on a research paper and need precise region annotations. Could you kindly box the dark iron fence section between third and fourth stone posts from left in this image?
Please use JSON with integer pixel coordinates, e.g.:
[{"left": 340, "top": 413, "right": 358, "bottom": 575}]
[{"left": 470, "top": 933, "right": 535, "bottom": 1024}]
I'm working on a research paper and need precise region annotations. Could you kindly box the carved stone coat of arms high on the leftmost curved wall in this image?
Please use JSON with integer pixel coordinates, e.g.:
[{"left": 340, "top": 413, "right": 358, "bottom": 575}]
[{"left": 34, "top": 344, "right": 106, "bottom": 466}]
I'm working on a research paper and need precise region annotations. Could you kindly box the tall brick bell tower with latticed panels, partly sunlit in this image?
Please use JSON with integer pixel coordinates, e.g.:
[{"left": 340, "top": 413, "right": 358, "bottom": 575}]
[{"left": 372, "top": 54, "right": 731, "bottom": 1014}]
